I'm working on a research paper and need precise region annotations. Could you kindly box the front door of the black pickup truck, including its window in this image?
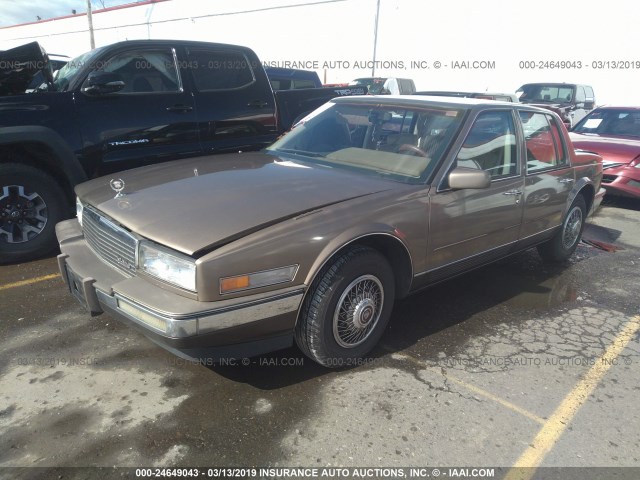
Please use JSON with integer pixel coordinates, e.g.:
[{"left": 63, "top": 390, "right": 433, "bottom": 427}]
[{"left": 75, "top": 46, "right": 201, "bottom": 175}]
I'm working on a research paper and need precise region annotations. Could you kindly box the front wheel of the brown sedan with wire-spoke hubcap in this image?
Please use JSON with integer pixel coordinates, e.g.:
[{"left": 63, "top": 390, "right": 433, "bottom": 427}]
[{"left": 295, "top": 247, "right": 395, "bottom": 368}]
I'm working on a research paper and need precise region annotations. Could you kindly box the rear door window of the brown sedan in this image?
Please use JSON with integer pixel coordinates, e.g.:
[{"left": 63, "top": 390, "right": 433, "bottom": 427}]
[{"left": 519, "top": 111, "right": 566, "bottom": 173}]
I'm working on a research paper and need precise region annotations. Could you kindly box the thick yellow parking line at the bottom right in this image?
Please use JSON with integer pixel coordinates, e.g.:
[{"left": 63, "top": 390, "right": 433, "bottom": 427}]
[{"left": 504, "top": 316, "right": 640, "bottom": 480}]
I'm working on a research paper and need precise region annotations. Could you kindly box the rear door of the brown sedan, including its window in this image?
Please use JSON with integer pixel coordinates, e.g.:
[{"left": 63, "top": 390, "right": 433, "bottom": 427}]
[{"left": 518, "top": 110, "right": 575, "bottom": 246}]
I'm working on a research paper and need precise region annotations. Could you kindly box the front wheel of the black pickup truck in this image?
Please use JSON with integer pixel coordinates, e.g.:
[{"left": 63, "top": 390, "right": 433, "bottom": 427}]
[{"left": 0, "top": 163, "right": 68, "bottom": 264}]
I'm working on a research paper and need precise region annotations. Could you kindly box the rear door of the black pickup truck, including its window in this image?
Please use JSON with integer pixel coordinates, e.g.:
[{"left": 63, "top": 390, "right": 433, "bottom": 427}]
[{"left": 186, "top": 46, "right": 277, "bottom": 153}]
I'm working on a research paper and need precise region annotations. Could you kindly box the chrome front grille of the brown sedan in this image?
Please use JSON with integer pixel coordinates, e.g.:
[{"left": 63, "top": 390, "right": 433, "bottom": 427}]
[{"left": 82, "top": 207, "right": 138, "bottom": 275}]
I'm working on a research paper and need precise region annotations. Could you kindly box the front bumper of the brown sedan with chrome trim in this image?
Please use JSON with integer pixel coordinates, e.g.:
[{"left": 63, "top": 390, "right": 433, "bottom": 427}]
[{"left": 56, "top": 219, "right": 304, "bottom": 361}]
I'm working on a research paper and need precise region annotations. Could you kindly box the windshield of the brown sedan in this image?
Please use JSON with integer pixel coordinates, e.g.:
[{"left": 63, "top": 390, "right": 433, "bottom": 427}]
[{"left": 267, "top": 102, "right": 465, "bottom": 184}]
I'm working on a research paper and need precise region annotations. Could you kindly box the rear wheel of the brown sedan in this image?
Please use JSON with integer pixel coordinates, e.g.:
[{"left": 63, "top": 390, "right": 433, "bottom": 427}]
[{"left": 538, "top": 195, "right": 587, "bottom": 262}]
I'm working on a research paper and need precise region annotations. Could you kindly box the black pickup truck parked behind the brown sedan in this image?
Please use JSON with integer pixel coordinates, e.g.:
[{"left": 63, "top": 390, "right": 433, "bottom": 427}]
[{"left": 0, "top": 40, "right": 366, "bottom": 263}]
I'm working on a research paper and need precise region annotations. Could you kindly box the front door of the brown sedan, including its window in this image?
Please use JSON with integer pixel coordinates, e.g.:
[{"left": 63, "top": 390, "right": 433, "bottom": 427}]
[{"left": 428, "top": 109, "right": 524, "bottom": 281}]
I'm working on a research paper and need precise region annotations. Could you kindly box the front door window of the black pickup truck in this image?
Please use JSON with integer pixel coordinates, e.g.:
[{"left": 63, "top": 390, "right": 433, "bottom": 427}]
[{"left": 102, "top": 49, "right": 180, "bottom": 94}]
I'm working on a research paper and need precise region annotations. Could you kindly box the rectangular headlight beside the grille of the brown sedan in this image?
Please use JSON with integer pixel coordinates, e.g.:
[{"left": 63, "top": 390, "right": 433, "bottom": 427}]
[{"left": 138, "top": 242, "right": 196, "bottom": 292}]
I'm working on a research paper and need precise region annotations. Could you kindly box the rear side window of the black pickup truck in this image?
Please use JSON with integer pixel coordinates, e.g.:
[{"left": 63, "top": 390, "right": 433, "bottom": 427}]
[{"left": 189, "top": 50, "right": 255, "bottom": 92}]
